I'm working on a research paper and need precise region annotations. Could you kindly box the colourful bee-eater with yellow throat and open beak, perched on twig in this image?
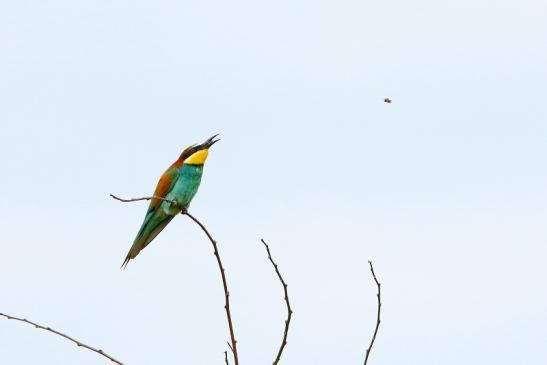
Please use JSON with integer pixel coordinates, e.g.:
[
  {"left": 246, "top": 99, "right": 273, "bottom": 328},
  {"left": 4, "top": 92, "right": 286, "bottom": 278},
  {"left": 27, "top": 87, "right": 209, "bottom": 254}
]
[{"left": 122, "top": 134, "right": 219, "bottom": 268}]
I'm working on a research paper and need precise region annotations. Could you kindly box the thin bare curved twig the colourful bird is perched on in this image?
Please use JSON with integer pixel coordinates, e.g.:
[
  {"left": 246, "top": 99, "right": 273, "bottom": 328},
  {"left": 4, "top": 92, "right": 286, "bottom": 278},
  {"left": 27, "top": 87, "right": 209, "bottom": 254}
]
[{"left": 110, "top": 194, "right": 239, "bottom": 365}]
